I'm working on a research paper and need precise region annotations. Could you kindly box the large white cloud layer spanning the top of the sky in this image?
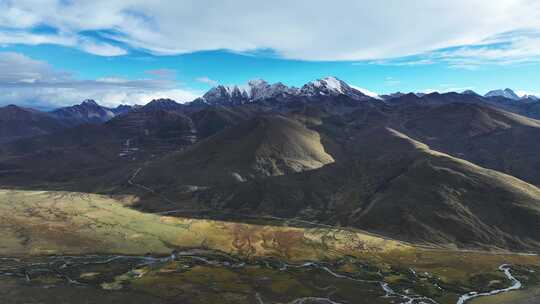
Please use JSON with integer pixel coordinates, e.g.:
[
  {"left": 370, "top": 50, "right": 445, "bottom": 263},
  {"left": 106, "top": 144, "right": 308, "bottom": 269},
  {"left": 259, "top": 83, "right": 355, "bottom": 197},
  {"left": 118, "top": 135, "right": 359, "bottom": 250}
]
[{"left": 0, "top": 0, "right": 540, "bottom": 63}]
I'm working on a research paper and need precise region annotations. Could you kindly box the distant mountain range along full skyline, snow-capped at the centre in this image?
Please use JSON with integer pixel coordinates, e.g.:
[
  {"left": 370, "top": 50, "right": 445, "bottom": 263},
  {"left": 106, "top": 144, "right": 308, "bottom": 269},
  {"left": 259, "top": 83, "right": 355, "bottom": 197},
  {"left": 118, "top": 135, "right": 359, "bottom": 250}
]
[{"left": 0, "top": 77, "right": 540, "bottom": 142}]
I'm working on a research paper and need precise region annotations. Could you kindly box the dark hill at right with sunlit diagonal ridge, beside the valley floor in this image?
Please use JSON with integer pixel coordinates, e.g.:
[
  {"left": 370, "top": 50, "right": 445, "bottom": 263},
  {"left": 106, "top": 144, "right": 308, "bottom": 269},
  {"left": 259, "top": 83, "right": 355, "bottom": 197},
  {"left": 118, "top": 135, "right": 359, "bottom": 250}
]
[{"left": 176, "top": 128, "right": 540, "bottom": 250}]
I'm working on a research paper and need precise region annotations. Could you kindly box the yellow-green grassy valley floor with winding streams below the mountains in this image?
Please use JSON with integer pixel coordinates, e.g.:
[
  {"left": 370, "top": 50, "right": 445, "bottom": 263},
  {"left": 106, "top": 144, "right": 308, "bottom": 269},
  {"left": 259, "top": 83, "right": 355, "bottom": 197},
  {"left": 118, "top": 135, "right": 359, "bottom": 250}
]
[{"left": 0, "top": 189, "right": 540, "bottom": 304}]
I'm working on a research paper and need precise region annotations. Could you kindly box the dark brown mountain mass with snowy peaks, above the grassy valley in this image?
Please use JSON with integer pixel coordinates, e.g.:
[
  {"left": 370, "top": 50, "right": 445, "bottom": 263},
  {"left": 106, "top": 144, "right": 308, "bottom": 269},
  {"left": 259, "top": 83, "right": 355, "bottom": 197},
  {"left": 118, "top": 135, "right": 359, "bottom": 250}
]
[{"left": 0, "top": 79, "right": 540, "bottom": 251}]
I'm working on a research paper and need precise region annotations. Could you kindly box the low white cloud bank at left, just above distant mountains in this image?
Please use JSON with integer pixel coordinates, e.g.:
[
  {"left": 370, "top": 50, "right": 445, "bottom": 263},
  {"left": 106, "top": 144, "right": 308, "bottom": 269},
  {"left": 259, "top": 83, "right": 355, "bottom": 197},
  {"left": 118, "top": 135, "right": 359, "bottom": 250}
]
[{"left": 0, "top": 52, "right": 201, "bottom": 108}]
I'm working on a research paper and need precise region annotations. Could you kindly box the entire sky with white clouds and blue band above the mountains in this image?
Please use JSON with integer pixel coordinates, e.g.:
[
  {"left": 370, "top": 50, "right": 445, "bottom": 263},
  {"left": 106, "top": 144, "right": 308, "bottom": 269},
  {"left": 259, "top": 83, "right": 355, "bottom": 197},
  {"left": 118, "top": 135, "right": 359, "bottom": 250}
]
[{"left": 0, "top": 0, "right": 540, "bottom": 107}]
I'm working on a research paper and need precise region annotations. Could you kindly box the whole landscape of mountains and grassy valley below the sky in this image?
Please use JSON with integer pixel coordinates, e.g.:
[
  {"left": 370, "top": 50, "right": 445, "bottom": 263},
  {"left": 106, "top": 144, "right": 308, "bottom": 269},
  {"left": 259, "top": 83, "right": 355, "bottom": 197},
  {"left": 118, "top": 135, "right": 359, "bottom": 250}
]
[{"left": 0, "top": 78, "right": 540, "bottom": 304}]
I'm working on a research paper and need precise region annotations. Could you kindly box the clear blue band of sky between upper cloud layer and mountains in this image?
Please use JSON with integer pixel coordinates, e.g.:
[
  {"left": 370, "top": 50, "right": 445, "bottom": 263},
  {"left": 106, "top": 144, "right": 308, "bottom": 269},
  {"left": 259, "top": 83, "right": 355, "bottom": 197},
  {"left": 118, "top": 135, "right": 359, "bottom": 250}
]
[{"left": 7, "top": 45, "right": 540, "bottom": 93}]
